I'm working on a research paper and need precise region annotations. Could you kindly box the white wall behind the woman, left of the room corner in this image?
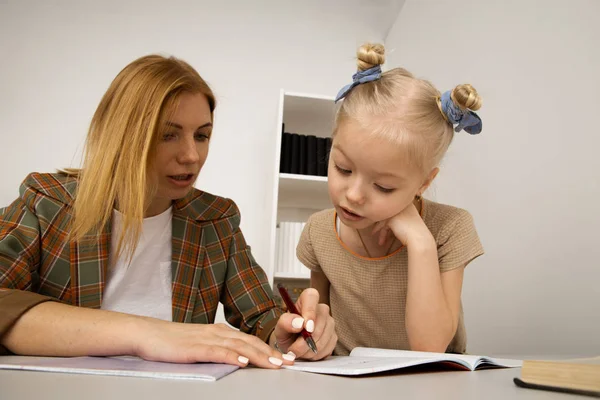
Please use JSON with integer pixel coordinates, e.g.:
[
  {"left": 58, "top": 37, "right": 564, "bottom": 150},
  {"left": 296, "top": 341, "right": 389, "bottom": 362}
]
[{"left": 0, "top": 0, "right": 400, "bottom": 282}]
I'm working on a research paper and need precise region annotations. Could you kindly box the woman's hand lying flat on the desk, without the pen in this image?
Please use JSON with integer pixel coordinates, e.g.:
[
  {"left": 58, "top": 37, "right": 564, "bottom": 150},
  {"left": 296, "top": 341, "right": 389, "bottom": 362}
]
[{"left": 134, "top": 318, "right": 293, "bottom": 369}]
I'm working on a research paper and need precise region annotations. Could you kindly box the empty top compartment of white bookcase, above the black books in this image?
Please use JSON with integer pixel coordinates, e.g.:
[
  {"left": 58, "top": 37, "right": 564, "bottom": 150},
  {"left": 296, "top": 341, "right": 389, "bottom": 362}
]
[{"left": 283, "top": 92, "right": 336, "bottom": 137}]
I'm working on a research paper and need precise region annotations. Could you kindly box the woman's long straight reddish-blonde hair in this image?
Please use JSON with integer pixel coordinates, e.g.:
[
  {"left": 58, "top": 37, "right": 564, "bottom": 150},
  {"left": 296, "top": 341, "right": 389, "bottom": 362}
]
[{"left": 65, "top": 55, "right": 216, "bottom": 257}]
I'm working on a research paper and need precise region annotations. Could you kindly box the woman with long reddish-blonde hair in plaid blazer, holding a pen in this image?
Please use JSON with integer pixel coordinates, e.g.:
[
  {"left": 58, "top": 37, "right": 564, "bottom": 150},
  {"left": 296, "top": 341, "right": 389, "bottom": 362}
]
[{"left": 0, "top": 56, "right": 337, "bottom": 368}]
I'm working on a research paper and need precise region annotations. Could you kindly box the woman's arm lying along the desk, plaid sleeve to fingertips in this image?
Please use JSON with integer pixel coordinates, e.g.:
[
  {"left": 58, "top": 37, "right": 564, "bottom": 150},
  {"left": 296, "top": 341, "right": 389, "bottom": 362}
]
[{"left": 0, "top": 195, "right": 281, "bottom": 368}]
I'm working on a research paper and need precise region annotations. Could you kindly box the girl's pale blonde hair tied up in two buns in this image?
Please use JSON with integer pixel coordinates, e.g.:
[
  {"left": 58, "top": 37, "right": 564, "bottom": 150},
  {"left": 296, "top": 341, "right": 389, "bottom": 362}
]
[{"left": 334, "top": 43, "right": 481, "bottom": 175}]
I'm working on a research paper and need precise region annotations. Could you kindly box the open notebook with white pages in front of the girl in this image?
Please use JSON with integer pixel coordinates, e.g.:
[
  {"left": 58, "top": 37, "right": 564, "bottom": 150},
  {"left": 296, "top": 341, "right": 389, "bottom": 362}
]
[{"left": 283, "top": 347, "right": 522, "bottom": 375}]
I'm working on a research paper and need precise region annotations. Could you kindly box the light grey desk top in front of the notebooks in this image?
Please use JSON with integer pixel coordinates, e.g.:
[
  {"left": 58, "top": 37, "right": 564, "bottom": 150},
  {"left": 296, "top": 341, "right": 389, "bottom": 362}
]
[{"left": 0, "top": 368, "right": 582, "bottom": 400}]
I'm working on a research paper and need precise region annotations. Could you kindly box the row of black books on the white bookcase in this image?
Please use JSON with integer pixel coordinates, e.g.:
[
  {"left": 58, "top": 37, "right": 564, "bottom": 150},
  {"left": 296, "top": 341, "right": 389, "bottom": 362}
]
[{"left": 279, "top": 132, "right": 331, "bottom": 176}]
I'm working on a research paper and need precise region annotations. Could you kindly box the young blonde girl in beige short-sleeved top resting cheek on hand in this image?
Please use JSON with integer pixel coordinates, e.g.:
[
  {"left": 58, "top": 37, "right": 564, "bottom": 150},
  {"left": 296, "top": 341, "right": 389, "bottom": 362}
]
[{"left": 297, "top": 44, "right": 483, "bottom": 355}]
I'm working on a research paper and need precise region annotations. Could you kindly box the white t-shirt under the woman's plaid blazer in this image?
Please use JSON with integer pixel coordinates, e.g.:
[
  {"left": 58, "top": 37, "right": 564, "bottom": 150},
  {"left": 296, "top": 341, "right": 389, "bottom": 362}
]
[{"left": 101, "top": 207, "right": 173, "bottom": 321}]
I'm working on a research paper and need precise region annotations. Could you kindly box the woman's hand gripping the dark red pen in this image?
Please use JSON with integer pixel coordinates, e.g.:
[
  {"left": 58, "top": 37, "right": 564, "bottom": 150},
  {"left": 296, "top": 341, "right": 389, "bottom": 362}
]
[{"left": 272, "top": 288, "right": 337, "bottom": 360}]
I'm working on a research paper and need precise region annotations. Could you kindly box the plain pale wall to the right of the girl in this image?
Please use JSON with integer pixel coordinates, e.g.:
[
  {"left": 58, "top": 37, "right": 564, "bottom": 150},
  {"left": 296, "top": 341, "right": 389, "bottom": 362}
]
[{"left": 386, "top": 0, "right": 600, "bottom": 355}]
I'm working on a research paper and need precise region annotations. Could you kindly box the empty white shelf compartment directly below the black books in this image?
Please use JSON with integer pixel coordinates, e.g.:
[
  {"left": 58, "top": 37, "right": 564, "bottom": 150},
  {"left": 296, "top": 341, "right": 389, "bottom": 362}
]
[{"left": 278, "top": 174, "right": 331, "bottom": 210}]
